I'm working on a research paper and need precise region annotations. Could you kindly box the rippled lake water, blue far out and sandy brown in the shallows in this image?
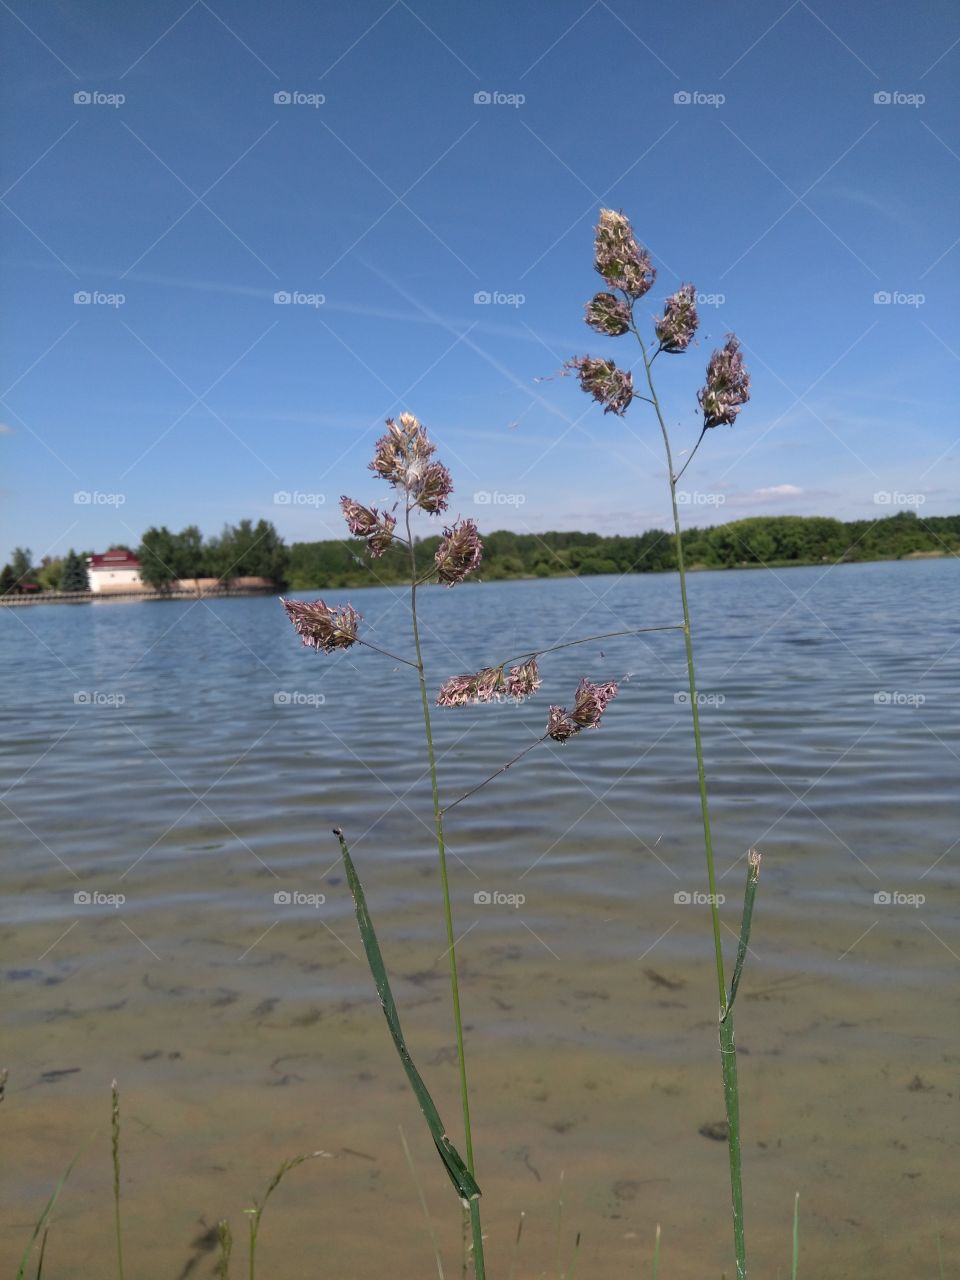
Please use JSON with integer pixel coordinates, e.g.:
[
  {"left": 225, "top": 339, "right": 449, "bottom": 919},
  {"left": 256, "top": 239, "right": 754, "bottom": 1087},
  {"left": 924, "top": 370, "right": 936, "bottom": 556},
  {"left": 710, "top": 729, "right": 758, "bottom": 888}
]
[{"left": 0, "top": 561, "right": 960, "bottom": 1280}]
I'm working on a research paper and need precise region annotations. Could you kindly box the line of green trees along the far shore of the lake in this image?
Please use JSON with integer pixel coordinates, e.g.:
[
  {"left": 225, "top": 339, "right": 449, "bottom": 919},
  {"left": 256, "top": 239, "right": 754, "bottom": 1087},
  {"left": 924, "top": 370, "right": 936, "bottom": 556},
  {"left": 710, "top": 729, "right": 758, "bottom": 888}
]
[{"left": 0, "top": 511, "right": 960, "bottom": 594}]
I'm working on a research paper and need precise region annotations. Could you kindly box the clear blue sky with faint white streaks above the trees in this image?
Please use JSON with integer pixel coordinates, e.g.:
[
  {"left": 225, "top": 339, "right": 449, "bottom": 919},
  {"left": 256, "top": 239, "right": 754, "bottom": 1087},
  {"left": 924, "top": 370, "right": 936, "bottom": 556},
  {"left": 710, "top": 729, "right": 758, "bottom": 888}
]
[{"left": 0, "top": 0, "right": 960, "bottom": 559}]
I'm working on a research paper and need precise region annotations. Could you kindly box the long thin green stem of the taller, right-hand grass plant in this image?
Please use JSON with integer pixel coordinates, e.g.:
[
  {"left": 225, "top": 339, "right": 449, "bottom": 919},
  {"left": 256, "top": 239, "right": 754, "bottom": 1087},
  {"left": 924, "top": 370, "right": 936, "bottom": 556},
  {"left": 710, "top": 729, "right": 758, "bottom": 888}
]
[{"left": 634, "top": 326, "right": 746, "bottom": 1280}]
